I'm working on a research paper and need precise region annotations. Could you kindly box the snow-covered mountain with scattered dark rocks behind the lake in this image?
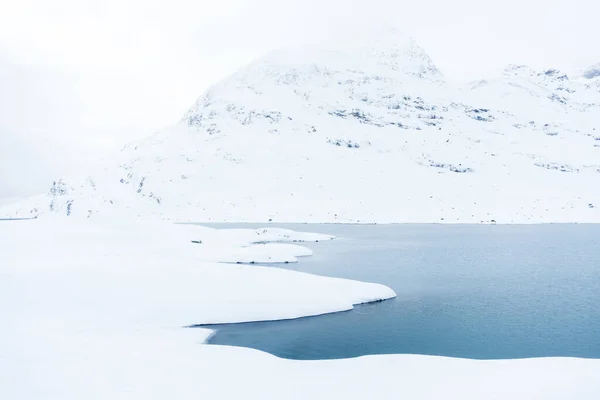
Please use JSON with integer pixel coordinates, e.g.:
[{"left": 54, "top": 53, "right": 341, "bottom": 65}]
[{"left": 4, "top": 32, "right": 600, "bottom": 223}]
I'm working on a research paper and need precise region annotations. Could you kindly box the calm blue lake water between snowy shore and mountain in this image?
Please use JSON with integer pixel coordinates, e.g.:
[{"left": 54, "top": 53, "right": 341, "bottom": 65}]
[{"left": 197, "top": 225, "right": 600, "bottom": 359}]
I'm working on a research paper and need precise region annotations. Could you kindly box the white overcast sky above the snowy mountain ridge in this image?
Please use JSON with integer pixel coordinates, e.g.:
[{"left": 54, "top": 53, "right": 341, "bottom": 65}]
[{"left": 0, "top": 0, "right": 600, "bottom": 202}]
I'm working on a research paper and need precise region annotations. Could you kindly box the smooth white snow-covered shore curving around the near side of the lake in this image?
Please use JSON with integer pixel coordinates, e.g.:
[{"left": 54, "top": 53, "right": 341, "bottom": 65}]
[{"left": 0, "top": 218, "right": 600, "bottom": 400}]
